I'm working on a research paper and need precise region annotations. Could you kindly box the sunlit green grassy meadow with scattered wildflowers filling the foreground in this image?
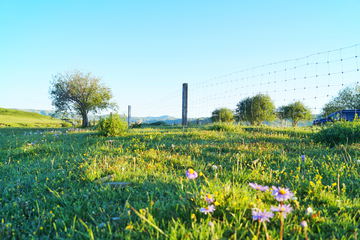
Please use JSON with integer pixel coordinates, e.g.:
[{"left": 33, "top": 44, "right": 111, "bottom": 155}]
[{"left": 0, "top": 126, "right": 360, "bottom": 239}]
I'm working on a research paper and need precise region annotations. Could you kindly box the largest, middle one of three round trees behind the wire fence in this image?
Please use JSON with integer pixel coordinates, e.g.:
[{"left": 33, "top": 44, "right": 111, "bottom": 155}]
[{"left": 235, "top": 93, "right": 275, "bottom": 125}]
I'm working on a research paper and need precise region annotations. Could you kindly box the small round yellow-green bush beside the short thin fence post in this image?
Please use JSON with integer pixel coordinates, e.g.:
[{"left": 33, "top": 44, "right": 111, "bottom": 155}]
[{"left": 97, "top": 113, "right": 128, "bottom": 137}]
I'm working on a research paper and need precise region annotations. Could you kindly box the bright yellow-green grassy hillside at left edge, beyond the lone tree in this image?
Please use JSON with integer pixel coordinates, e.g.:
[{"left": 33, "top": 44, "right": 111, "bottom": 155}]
[{"left": 0, "top": 108, "right": 62, "bottom": 127}]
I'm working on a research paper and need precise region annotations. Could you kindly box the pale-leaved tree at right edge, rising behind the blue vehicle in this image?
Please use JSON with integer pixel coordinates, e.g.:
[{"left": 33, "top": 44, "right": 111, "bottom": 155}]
[{"left": 321, "top": 86, "right": 360, "bottom": 117}]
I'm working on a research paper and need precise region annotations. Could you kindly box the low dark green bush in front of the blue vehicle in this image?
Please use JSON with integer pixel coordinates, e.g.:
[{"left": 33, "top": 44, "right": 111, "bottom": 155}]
[{"left": 312, "top": 119, "right": 360, "bottom": 147}]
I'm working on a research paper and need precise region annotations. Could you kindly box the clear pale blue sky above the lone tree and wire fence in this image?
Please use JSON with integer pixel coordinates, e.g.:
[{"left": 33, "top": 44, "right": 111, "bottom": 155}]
[{"left": 0, "top": 0, "right": 360, "bottom": 116}]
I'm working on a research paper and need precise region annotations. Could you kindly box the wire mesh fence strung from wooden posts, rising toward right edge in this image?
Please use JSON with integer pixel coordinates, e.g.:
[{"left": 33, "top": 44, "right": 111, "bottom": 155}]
[{"left": 133, "top": 44, "right": 360, "bottom": 123}]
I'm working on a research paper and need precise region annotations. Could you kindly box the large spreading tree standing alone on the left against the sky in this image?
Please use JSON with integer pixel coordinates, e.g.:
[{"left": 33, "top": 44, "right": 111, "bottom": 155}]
[{"left": 49, "top": 70, "right": 117, "bottom": 127}]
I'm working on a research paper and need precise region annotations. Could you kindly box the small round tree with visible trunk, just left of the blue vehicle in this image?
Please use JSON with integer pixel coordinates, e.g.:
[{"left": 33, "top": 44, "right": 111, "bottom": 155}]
[{"left": 285, "top": 101, "right": 311, "bottom": 127}]
